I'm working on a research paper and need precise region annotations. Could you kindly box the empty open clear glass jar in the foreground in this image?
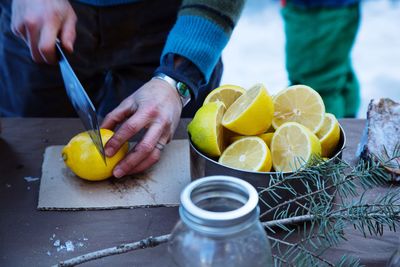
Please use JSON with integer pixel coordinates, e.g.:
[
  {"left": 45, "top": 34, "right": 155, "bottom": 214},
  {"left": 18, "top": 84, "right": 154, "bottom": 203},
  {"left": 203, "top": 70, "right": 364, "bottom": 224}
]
[{"left": 168, "top": 176, "right": 272, "bottom": 267}]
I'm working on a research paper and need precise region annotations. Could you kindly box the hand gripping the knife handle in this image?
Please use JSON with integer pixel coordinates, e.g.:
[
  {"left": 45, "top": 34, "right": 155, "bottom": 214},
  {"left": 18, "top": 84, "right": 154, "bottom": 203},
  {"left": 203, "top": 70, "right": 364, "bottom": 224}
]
[{"left": 11, "top": 0, "right": 77, "bottom": 64}]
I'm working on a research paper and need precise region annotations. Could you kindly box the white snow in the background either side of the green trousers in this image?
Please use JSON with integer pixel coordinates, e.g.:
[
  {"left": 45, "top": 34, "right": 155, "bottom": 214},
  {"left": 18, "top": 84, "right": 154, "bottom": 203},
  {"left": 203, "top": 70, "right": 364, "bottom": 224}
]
[{"left": 222, "top": 0, "right": 400, "bottom": 118}]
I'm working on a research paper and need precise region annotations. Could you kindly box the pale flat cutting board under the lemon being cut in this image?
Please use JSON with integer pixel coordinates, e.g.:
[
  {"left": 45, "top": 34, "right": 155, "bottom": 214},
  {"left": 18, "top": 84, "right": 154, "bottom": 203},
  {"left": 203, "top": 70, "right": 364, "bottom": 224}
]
[{"left": 38, "top": 140, "right": 190, "bottom": 210}]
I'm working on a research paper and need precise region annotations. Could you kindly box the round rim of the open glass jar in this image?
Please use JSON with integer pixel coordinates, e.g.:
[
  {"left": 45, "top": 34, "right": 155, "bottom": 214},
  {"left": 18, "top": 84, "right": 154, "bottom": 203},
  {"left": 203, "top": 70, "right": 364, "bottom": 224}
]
[{"left": 181, "top": 175, "right": 258, "bottom": 222}]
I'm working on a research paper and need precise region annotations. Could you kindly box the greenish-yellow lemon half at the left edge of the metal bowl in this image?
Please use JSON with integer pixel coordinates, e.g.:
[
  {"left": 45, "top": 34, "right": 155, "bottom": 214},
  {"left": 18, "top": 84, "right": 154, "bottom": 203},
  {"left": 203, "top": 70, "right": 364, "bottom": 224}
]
[{"left": 188, "top": 101, "right": 225, "bottom": 157}]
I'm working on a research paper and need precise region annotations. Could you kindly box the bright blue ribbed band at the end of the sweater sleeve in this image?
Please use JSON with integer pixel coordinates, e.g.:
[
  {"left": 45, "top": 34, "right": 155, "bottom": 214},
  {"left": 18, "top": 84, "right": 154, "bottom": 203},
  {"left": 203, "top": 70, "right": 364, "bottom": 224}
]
[{"left": 161, "top": 16, "right": 228, "bottom": 83}]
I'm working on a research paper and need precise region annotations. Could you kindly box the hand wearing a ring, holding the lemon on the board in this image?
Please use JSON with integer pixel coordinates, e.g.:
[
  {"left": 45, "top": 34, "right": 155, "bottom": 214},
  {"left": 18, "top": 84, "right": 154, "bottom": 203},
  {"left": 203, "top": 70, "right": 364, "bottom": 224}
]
[{"left": 101, "top": 79, "right": 182, "bottom": 178}]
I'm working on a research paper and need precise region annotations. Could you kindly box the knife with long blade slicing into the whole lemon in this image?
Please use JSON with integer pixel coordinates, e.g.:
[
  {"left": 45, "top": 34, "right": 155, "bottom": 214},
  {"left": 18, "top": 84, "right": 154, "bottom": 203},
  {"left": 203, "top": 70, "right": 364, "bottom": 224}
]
[{"left": 56, "top": 40, "right": 107, "bottom": 165}]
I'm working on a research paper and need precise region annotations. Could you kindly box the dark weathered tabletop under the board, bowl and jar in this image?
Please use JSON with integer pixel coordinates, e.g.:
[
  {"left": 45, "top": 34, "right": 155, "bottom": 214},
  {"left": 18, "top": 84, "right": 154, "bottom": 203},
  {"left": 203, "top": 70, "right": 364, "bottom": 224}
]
[{"left": 0, "top": 118, "right": 400, "bottom": 266}]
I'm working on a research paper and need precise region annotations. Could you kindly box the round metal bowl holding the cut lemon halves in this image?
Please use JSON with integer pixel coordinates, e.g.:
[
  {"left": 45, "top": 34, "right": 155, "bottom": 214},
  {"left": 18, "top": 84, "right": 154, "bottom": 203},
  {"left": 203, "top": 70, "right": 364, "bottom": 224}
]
[{"left": 189, "top": 125, "right": 346, "bottom": 220}]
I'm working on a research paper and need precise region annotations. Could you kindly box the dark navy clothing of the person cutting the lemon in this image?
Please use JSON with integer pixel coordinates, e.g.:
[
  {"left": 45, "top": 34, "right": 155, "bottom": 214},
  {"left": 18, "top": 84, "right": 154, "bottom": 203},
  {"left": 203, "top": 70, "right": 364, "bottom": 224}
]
[{"left": 0, "top": 0, "right": 222, "bottom": 117}]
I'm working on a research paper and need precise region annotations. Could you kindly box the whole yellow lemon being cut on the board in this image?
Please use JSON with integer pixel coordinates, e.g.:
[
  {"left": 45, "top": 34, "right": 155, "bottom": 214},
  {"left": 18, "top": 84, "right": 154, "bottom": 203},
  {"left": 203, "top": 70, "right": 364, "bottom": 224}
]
[{"left": 62, "top": 129, "right": 128, "bottom": 181}]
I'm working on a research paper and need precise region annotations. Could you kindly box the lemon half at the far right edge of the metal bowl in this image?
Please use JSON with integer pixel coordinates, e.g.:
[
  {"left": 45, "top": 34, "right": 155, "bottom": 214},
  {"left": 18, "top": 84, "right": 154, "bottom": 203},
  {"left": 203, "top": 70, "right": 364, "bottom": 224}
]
[{"left": 317, "top": 113, "right": 340, "bottom": 157}]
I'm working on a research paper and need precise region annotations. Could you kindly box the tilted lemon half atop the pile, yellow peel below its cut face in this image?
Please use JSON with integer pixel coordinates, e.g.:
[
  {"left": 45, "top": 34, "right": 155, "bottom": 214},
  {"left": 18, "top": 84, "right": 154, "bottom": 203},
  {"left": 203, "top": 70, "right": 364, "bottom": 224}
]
[{"left": 222, "top": 84, "right": 274, "bottom": 135}]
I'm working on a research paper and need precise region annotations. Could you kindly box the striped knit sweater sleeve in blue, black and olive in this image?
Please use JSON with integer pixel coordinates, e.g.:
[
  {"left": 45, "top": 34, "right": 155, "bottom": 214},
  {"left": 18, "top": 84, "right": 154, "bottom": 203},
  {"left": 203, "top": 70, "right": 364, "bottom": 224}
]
[{"left": 161, "top": 0, "right": 245, "bottom": 82}]
